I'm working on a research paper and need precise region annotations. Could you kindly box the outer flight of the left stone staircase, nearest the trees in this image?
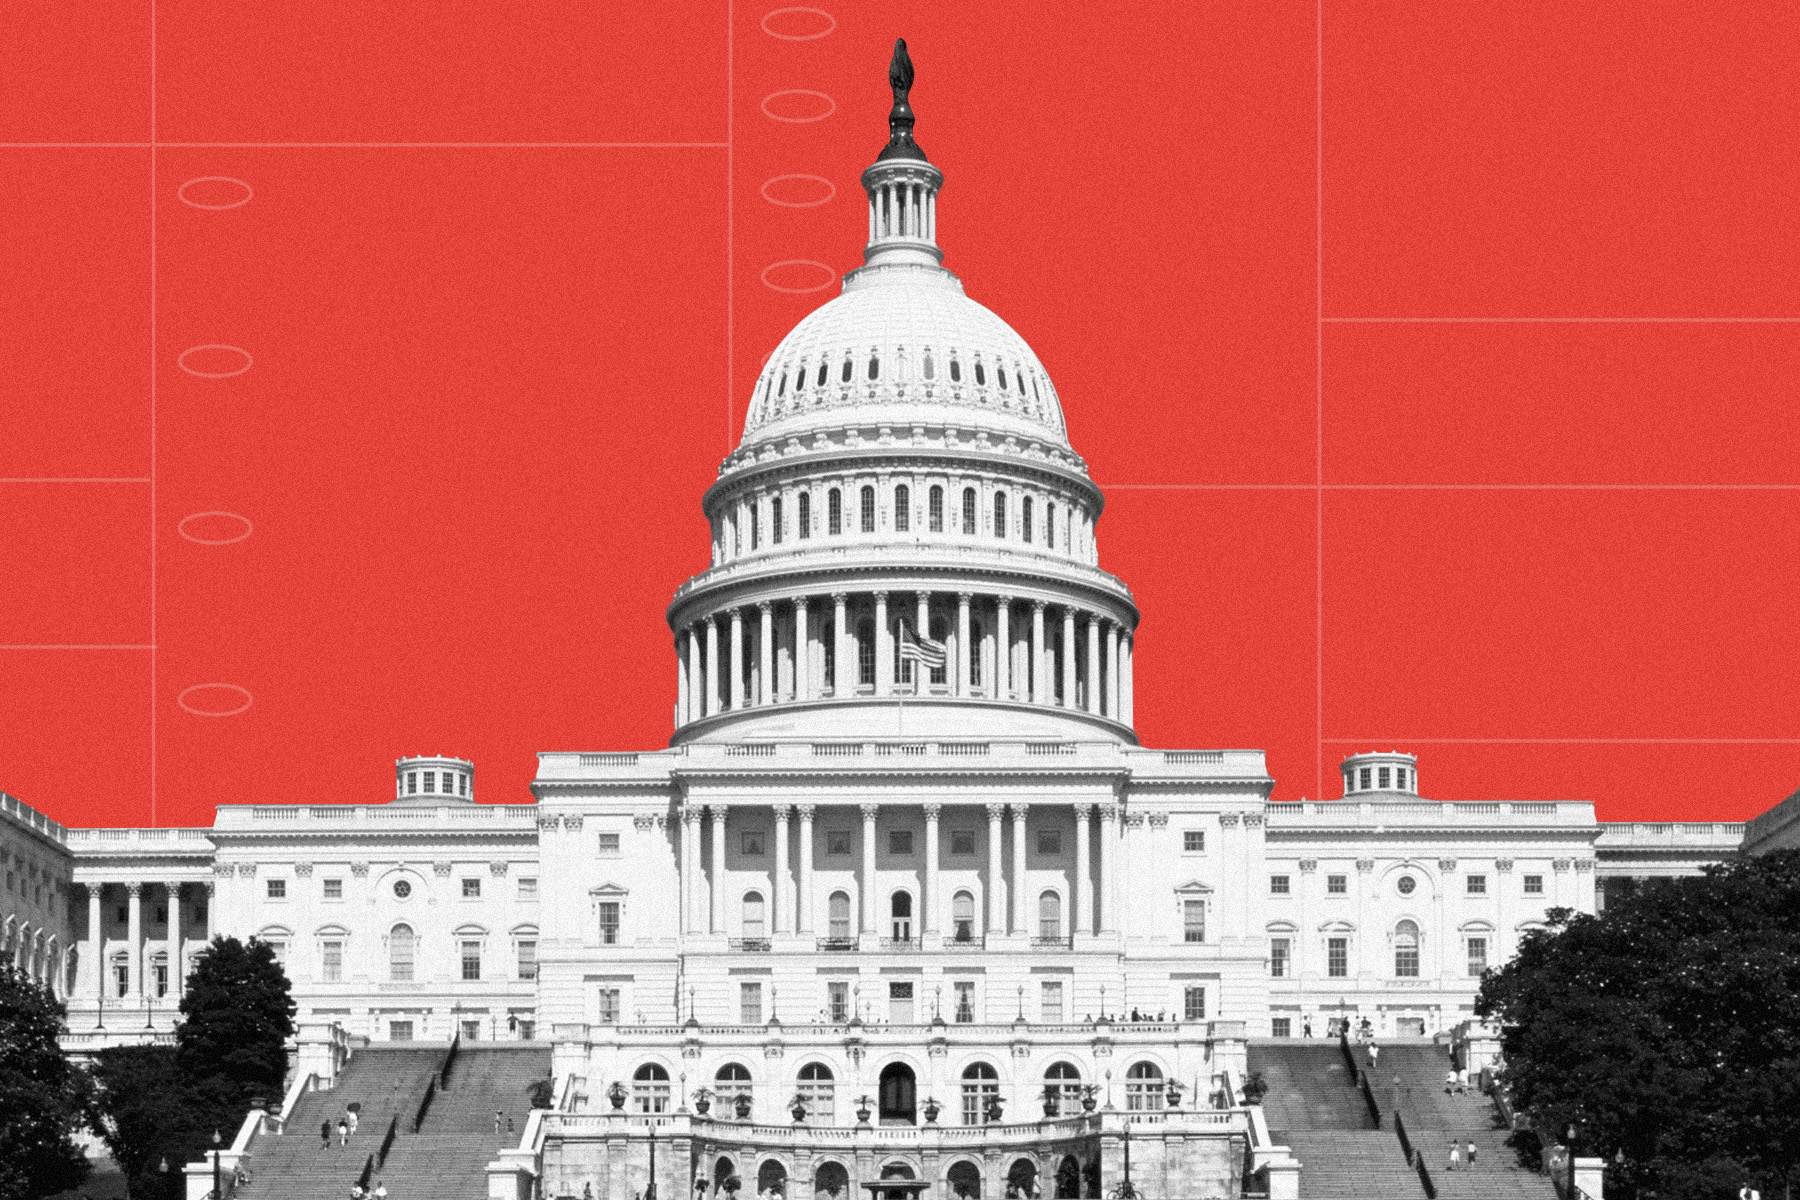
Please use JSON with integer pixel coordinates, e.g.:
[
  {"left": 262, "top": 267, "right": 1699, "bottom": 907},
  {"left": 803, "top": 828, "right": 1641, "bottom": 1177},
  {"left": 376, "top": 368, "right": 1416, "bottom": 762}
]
[{"left": 236, "top": 1045, "right": 444, "bottom": 1200}]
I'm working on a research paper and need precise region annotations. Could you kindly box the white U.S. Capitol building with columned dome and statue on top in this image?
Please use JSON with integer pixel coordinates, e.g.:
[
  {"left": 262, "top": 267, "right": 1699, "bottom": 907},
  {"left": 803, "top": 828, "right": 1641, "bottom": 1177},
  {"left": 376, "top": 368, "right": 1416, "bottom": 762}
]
[{"left": 7, "top": 42, "right": 1771, "bottom": 1196}]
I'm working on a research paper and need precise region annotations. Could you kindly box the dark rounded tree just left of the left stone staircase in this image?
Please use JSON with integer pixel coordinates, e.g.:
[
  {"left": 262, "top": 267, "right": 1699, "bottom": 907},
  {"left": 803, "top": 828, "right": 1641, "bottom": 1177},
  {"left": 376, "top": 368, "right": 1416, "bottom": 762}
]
[{"left": 175, "top": 936, "right": 295, "bottom": 1128}]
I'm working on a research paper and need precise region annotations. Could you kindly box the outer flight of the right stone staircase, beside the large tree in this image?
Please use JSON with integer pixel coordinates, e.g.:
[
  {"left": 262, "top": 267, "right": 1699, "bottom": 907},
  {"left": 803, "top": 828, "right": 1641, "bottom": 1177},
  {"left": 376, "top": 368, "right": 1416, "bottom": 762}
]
[{"left": 1373, "top": 1045, "right": 1555, "bottom": 1200}]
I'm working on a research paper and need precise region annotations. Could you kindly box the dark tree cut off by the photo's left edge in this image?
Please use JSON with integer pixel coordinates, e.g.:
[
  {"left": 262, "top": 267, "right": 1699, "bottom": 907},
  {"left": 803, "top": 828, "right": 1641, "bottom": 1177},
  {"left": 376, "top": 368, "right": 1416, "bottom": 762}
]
[{"left": 0, "top": 961, "right": 88, "bottom": 1200}]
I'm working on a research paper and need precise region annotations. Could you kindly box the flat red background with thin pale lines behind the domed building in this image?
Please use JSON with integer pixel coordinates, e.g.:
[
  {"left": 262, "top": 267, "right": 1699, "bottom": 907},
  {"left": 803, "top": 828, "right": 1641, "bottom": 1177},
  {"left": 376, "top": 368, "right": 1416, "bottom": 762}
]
[{"left": 0, "top": 0, "right": 1800, "bottom": 824}]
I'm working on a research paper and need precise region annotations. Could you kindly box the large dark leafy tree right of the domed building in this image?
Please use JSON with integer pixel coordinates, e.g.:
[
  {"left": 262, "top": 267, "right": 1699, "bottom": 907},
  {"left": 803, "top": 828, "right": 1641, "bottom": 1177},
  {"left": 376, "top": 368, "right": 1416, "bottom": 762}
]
[{"left": 1476, "top": 851, "right": 1800, "bottom": 1200}]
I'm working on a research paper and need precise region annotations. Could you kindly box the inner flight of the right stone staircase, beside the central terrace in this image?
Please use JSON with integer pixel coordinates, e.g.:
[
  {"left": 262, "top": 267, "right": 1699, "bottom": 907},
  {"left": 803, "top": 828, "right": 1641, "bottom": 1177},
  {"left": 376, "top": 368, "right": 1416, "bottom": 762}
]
[{"left": 1249, "top": 1040, "right": 1426, "bottom": 1200}]
